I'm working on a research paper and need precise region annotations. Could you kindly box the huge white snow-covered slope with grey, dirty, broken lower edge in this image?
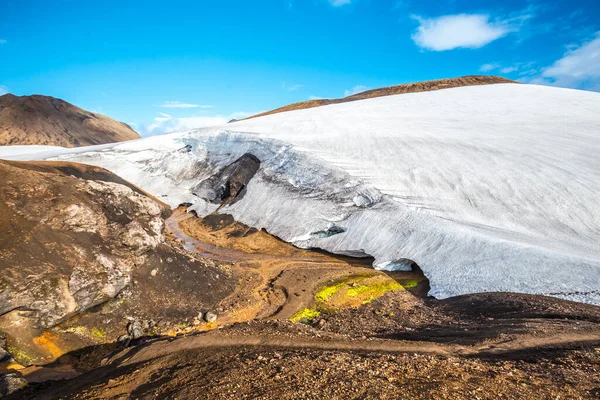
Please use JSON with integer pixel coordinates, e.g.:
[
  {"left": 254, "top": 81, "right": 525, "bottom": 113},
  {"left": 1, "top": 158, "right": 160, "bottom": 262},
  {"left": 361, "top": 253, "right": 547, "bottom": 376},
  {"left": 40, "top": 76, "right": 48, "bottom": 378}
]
[{"left": 5, "top": 84, "right": 600, "bottom": 304}]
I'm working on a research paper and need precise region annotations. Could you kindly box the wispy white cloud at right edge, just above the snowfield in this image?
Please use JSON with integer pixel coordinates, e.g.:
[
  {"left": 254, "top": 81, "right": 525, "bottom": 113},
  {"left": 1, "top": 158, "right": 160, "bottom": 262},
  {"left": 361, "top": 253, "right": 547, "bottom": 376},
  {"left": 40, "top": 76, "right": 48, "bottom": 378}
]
[{"left": 528, "top": 32, "right": 600, "bottom": 91}]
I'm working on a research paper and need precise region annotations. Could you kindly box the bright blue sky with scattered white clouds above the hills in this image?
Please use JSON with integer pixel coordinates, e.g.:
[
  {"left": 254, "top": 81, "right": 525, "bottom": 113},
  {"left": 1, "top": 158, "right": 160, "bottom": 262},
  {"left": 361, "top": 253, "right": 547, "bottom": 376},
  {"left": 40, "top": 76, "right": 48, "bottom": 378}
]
[{"left": 0, "top": 0, "right": 600, "bottom": 135}]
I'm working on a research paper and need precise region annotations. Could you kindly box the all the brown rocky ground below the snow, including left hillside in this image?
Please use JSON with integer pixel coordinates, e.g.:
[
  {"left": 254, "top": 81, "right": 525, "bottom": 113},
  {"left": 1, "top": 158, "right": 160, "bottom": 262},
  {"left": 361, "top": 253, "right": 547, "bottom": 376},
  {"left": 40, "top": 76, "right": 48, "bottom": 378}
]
[{"left": 0, "top": 162, "right": 600, "bottom": 399}]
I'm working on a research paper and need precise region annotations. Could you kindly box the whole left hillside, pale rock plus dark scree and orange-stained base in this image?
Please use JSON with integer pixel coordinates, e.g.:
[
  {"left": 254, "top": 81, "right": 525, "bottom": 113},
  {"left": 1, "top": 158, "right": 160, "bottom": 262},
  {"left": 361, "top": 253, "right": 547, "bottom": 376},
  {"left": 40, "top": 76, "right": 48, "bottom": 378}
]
[{"left": 0, "top": 160, "right": 235, "bottom": 365}]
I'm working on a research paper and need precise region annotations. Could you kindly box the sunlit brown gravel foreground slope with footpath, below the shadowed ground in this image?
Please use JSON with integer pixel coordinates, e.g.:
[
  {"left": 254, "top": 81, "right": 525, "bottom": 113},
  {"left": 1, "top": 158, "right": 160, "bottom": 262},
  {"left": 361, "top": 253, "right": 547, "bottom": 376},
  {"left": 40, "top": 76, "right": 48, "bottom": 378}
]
[{"left": 15, "top": 321, "right": 600, "bottom": 399}]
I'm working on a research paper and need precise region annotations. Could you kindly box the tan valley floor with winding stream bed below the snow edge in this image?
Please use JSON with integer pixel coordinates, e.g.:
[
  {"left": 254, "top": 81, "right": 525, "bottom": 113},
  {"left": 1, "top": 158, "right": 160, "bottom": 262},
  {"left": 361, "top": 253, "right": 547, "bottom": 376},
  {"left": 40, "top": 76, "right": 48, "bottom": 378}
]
[{"left": 167, "top": 209, "right": 382, "bottom": 324}]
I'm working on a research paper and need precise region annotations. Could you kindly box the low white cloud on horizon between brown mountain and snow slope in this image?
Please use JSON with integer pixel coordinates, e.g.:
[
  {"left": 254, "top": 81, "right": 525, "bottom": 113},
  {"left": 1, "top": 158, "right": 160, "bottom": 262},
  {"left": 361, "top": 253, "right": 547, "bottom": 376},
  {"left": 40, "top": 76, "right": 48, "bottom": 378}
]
[{"left": 141, "top": 112, "right": 258, "bottom": 136}]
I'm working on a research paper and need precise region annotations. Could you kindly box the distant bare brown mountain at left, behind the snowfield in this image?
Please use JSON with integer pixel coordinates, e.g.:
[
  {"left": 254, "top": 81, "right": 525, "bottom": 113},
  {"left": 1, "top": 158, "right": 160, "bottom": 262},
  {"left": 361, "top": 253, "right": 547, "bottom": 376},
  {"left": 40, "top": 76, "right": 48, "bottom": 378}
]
[{"left": 0, "top": 94, "right": 140, "bottom": 147}]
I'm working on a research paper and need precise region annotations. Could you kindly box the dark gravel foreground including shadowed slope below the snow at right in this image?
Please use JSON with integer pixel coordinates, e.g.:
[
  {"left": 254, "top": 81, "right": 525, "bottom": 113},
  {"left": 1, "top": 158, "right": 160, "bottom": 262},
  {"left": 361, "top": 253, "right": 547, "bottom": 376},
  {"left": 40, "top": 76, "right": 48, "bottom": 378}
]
[{"left": 5, "top": 291, "right": 600, "bottom": 399}]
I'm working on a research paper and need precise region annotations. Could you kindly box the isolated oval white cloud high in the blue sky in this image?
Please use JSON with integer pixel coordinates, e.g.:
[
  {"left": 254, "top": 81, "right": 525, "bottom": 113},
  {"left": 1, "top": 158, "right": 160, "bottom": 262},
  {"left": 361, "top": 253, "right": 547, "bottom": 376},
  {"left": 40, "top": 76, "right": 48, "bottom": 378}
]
[{"left": 411, "top": 14, "right": 516, "bottom": 51}]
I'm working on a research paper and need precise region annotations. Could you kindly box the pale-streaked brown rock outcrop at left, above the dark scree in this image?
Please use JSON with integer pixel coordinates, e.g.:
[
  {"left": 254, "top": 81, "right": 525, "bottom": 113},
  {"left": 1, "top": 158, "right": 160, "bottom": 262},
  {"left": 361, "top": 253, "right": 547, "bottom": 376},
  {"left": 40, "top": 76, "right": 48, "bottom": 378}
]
[{"left": 0, "top": 159, "right": 164, "bottom": 327}]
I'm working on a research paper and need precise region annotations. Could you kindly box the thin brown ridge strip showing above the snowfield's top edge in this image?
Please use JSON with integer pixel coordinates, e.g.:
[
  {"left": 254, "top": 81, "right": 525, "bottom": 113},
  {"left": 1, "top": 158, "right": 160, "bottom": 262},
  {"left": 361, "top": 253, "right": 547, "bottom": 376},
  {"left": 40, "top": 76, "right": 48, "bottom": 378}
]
[{"left": 239, "top": 75, "right": 517, "bottom": 119}]
